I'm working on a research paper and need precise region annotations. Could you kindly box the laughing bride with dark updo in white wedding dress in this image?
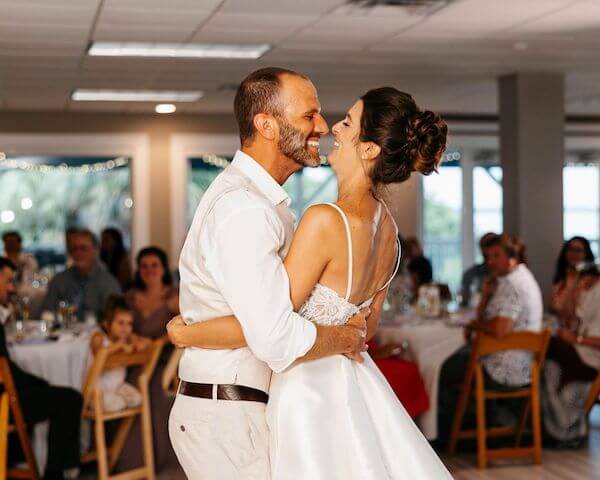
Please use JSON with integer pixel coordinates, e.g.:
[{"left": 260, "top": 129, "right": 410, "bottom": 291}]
[{"left": 169, "top": 87, "right": 452, "bottom": 480}]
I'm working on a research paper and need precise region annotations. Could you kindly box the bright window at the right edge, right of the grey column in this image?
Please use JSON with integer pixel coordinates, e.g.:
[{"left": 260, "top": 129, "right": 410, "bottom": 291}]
[{"left": 563, "top": 164, "right": 600, "bottom": 256}]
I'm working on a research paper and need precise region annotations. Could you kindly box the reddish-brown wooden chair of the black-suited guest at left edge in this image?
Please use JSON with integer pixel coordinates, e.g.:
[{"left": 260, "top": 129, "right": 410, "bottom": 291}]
[{"left": 0, "top": 357, "right": 40, "bottom": 480}]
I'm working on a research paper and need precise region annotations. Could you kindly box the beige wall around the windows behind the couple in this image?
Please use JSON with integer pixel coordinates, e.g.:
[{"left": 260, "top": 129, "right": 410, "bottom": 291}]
[{"left": 0, "top": 111, "right": 419, "bottom": 262}]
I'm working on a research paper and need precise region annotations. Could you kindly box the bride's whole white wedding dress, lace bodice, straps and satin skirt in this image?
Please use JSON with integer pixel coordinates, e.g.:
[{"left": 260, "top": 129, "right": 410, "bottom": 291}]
[{"left": 267, "top": 204, "right": 452, "bottom": 480}]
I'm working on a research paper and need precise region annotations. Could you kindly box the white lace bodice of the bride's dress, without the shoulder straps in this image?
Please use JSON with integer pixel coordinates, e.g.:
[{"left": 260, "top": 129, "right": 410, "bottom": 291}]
[{"left": 298, "top": 283, "right": 372, "bottom": 325}]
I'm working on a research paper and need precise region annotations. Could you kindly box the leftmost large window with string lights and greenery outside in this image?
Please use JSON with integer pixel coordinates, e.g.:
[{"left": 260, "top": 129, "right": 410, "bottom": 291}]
[{"left": 0, "top": 156, "right": 133, "bottom": 265}]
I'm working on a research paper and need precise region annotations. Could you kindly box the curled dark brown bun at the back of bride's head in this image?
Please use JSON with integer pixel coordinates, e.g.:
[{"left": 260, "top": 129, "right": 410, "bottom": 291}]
[{"left": 407, "top": 110, "right": 448, "bottom": 175}]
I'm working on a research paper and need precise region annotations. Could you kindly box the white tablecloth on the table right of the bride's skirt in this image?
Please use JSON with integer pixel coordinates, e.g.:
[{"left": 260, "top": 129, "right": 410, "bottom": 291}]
[{"left": 376, "top": 313, "right": 471, "bottom": 440}]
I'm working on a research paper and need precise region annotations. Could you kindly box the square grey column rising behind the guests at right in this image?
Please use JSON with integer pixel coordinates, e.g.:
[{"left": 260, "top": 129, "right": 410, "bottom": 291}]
[{"left": 499, "top": 73, "right": 565, "bottom": 299}]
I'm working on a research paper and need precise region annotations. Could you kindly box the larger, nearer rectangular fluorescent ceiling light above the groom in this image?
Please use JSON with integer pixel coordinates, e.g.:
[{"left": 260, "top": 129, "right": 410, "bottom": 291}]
[{"left": 88, "top": 42, "right": 271, "bottom": 59}]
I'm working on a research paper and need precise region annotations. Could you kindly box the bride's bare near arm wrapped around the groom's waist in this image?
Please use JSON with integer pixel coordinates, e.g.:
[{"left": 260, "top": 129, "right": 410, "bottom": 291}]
[{"left": 167, "top": 205, "right": 337, "bottom": 348}]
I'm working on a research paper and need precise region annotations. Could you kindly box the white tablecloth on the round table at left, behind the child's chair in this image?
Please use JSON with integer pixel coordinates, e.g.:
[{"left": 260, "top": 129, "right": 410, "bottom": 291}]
[{"left": 8, "top": 333, "right": 90, "bottom": 473}]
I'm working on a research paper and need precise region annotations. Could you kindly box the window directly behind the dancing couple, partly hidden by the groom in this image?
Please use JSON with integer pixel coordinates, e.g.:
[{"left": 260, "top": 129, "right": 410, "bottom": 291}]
[{"left": 187, "top": 155, "right": 337, "bottom": 224}]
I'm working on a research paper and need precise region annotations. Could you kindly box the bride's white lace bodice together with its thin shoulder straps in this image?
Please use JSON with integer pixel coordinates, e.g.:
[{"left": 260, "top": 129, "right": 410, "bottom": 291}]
[{"left": 298, "top": 203, "right": 400, "bottom": 325}]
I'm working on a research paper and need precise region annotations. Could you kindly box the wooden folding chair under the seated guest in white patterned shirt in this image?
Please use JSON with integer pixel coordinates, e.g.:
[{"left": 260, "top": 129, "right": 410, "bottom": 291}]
[{"left": 448, "top": 330, "right": 550, "bottom": 468}]
